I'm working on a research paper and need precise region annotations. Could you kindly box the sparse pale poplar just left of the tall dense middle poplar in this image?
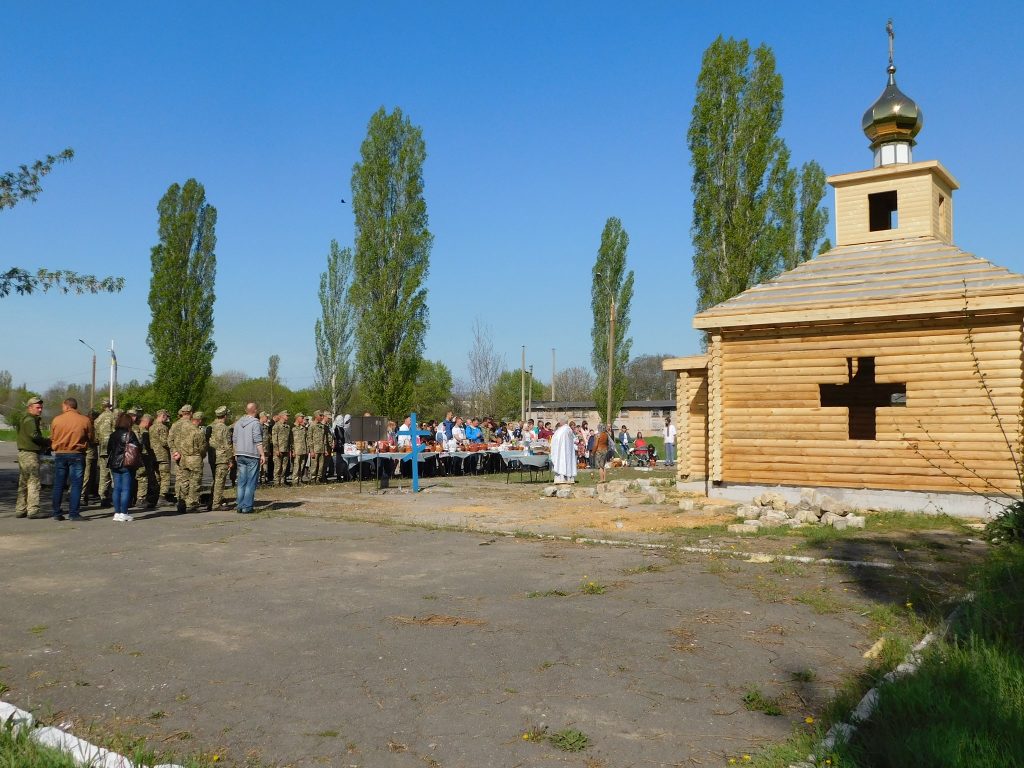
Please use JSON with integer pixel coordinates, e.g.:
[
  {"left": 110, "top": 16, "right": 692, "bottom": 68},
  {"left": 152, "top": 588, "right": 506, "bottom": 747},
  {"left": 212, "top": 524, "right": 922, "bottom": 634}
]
[{"left": 313, "top": 240, "right": 355, "bottom": 414}]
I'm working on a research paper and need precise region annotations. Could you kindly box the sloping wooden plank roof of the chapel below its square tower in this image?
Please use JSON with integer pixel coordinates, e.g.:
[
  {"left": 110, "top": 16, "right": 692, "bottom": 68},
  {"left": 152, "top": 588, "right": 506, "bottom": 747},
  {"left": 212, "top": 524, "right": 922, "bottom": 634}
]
[{"left": 693, "top": 238, "right": 1024, "bottom": 329}]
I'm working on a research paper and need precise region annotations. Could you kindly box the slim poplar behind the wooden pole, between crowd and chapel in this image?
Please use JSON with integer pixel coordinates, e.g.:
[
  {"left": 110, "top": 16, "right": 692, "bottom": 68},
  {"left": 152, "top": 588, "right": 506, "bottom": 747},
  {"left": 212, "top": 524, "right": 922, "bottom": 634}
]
[{"left": 590, "top": 216, "right": 633, "bottom": 424}]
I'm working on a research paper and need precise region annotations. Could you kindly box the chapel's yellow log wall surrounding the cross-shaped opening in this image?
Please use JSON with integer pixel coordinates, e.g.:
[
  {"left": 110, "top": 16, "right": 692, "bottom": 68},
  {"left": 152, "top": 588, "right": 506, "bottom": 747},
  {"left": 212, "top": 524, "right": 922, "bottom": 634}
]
[{"left": 709, "top": 313, "right": 1024, "bottom": 494}]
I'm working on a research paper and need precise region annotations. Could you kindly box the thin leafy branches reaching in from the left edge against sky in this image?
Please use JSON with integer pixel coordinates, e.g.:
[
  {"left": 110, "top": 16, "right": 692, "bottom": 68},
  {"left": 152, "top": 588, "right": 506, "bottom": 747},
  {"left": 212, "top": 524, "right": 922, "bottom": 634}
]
[{"left": 0, "top": 146, "right": 125, "bottom": 298}]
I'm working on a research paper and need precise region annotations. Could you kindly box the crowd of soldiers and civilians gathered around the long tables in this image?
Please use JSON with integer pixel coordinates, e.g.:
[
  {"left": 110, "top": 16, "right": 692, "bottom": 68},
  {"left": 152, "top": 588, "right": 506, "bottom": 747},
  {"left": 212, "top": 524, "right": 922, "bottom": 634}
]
[{"left": 15, "top": 397, "right": 675, "bottom": 522}]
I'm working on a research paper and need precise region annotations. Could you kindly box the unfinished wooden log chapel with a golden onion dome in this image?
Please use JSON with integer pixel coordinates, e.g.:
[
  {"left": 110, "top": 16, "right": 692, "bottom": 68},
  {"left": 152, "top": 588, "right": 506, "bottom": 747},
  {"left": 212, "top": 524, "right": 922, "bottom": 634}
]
[{"left": 664, "top": 28, "right": 1024, "bottom": 514}]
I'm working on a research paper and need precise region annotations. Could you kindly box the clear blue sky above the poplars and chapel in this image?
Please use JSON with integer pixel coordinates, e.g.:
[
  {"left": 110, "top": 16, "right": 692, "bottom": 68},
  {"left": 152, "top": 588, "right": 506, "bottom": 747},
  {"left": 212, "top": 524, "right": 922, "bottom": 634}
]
[{"left": 0, "top": 1, "right": 1024, "bottom": 397}]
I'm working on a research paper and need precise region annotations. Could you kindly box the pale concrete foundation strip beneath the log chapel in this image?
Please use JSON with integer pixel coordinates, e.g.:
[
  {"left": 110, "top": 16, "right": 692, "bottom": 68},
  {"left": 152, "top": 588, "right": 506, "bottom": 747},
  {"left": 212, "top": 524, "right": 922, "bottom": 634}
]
[{"left": 676, "top": 480, "right": 1015, "bottom": 518}]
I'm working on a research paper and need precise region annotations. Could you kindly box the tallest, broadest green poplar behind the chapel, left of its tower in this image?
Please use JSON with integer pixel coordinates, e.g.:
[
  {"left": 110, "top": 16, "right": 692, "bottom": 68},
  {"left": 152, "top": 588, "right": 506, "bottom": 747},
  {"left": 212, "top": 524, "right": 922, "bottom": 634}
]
[{"left": 687, "top": 36, "right": 796, "bottom": 310}]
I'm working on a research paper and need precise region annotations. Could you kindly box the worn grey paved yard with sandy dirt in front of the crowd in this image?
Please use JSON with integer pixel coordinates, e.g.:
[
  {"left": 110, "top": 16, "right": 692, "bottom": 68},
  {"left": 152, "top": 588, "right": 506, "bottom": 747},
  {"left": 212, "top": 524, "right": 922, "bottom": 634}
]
[{"left": 0, "top": 445, "right": 980, "bottom": 768}]
